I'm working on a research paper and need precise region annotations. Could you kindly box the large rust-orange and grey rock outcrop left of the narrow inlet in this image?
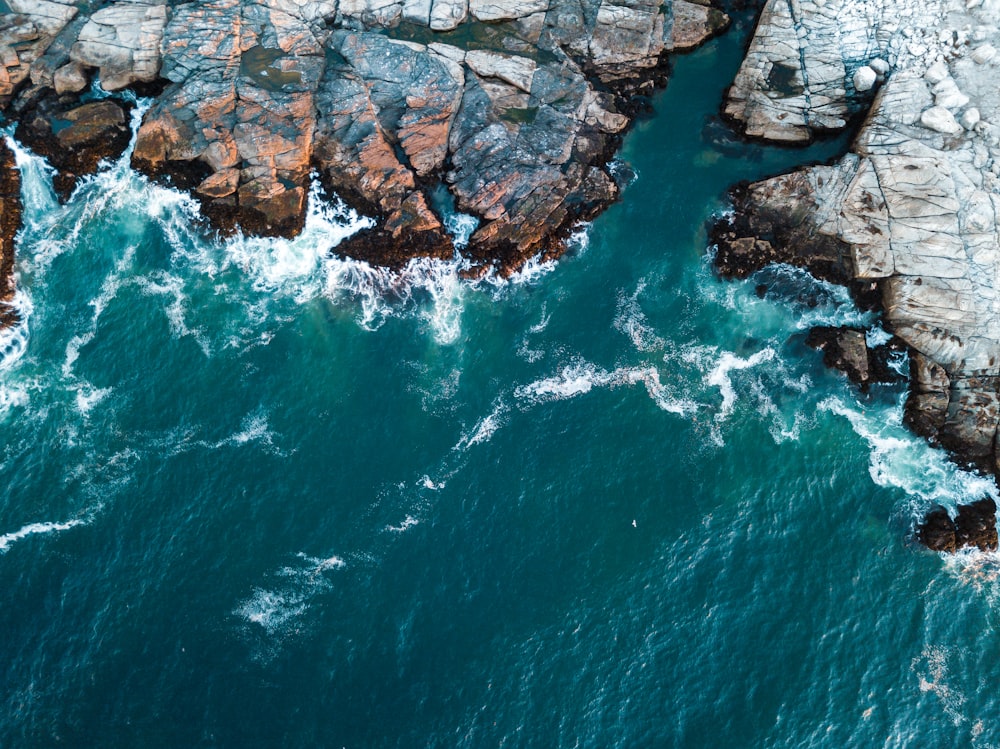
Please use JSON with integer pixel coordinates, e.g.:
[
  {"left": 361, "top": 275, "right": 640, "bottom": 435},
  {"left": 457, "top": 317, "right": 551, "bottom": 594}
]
[{"left": 0, "top": 0, "right": 726, "bottom": 268}]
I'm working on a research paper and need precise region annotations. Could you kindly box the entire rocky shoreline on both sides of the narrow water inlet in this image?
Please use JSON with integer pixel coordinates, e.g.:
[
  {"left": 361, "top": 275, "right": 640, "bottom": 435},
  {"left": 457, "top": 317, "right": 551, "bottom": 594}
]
[{"left": 0, "top": 0, "right": 1000, "bottom": 548}]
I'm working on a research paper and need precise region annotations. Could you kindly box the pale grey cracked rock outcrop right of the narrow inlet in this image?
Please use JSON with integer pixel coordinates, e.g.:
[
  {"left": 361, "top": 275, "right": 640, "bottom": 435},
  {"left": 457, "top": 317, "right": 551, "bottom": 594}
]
[{"left": 715, "top": 0, "right": 1000, "bottom": 470}]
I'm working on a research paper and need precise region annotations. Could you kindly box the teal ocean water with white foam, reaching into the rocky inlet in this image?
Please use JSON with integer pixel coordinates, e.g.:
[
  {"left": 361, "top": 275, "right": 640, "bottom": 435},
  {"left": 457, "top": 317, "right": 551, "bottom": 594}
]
[{"left": 0, "top": 18, "right": 1000, "bottom": 749}]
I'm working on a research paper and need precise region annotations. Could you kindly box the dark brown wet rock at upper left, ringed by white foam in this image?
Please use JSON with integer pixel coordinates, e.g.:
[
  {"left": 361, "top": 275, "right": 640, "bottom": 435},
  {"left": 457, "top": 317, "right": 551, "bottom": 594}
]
[{"left": 15, "top": 96, "right": 131, "bottom": 199}]
